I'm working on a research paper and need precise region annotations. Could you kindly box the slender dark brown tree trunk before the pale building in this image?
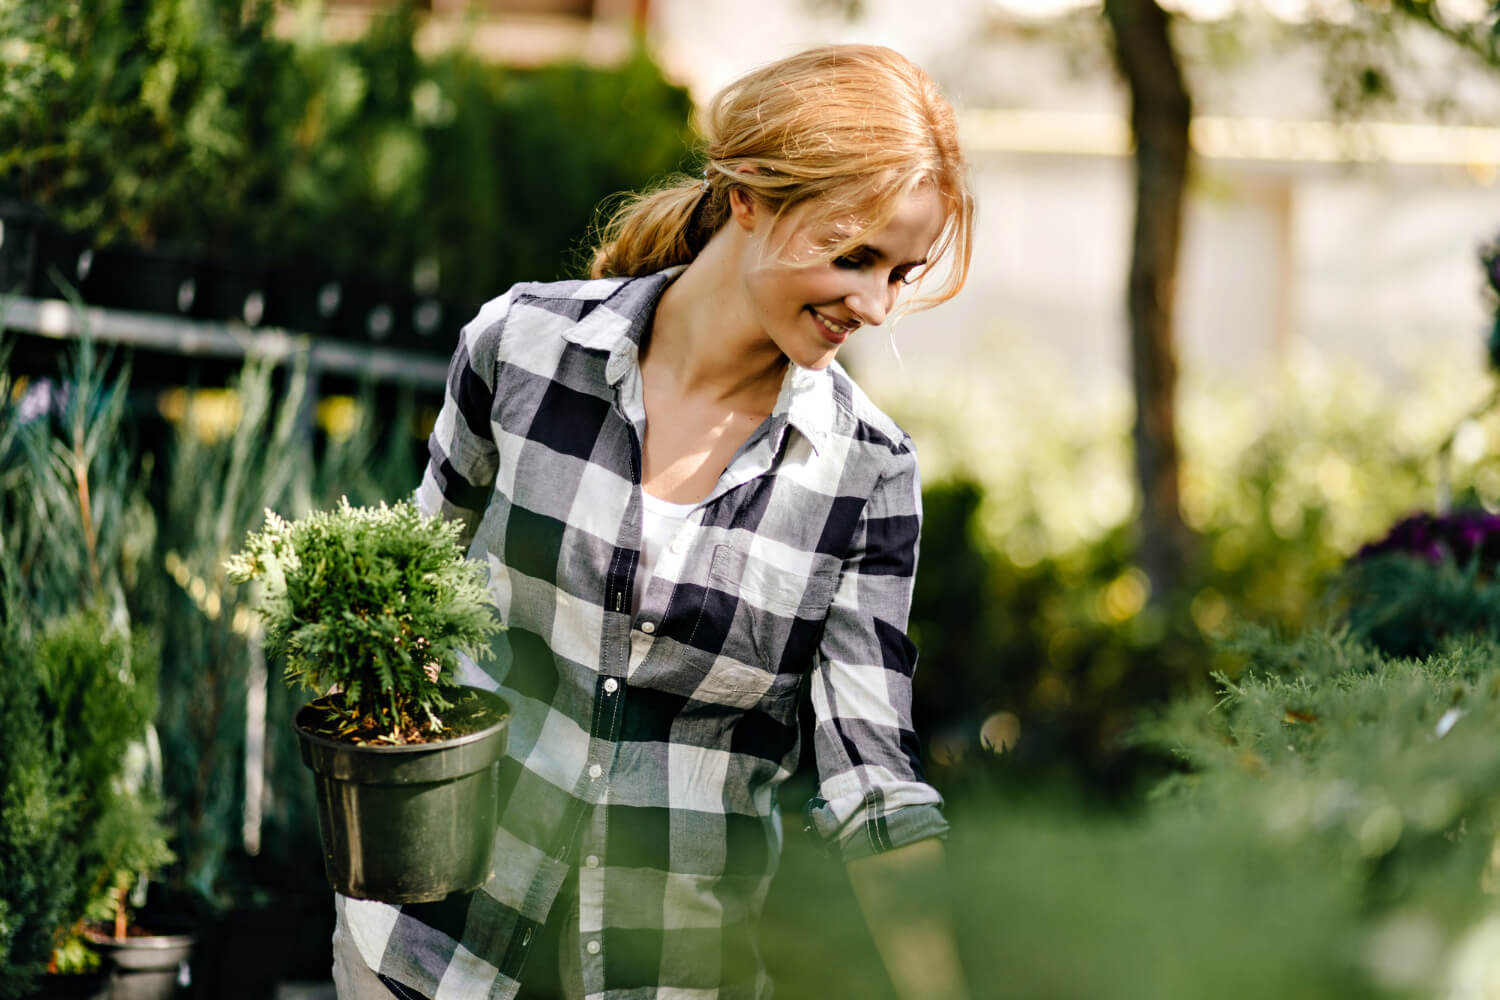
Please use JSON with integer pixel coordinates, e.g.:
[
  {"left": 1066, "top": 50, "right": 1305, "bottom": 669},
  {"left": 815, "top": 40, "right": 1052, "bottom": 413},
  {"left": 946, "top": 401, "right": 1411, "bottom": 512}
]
[{"left": 1104, "top": 0, "right": 1193, "bottom": 600}]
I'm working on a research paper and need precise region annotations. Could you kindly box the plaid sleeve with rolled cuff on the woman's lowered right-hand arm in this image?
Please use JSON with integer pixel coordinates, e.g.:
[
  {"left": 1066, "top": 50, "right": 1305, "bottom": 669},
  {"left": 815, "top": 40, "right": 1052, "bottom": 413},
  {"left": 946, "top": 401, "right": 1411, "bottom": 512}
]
[{"left": 807, "top": 441, "right": 948, "bottom": 861}]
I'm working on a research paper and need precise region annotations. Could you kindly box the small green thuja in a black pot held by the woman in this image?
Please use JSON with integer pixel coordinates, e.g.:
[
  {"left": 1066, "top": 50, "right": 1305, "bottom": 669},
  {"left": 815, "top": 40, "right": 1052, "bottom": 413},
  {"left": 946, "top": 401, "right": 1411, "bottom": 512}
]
[{"left": 227, "top": 499, "right": 509, "bottom": 903}]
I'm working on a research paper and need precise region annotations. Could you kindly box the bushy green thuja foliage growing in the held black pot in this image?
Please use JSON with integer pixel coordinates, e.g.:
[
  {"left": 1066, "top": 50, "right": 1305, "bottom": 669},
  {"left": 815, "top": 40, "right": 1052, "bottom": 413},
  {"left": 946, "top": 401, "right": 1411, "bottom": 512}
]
[{"left": 225, "top": 499, "right": 500, "bottom": 744}]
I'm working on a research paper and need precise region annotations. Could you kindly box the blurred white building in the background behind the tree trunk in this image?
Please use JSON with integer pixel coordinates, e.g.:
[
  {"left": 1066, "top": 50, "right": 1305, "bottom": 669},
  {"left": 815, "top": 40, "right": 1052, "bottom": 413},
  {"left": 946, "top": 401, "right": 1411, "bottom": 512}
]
[{"left": 651, "top": 0, "right": 1500, "bottom": 381}]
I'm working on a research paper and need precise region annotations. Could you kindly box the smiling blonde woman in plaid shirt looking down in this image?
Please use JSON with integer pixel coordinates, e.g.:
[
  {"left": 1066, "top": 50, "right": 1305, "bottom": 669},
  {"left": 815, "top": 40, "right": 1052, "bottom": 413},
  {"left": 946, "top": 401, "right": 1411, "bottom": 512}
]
[{"left": 335, "top": 46, "right": 974, "bottom": 1000}]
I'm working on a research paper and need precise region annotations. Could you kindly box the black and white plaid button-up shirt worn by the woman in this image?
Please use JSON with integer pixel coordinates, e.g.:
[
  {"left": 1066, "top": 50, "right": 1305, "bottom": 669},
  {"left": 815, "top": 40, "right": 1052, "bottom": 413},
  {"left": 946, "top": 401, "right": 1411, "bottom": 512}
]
[{"left": 339, "top": 271, "right": 947, "bottom": 1000}]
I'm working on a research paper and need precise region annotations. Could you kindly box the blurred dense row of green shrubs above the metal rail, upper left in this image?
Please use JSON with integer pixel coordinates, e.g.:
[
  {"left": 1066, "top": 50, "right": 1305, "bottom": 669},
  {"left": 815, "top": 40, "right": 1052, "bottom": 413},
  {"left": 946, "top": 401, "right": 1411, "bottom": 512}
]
[{"left": 0, "top": 0, "right": 692, "bottom": 303}]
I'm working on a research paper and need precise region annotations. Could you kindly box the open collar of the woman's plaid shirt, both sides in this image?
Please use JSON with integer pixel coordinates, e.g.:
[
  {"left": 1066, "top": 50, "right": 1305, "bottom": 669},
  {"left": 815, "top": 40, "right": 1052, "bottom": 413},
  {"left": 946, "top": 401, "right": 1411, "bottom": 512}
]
[{"left": 563, "top": 265, "right": 837, "bottom": 451}]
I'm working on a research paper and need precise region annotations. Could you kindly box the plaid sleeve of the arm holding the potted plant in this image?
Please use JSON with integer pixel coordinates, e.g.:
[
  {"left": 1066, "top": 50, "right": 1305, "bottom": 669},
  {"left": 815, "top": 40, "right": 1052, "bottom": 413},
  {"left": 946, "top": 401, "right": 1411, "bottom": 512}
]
[{"left": 416, "top": 292, "right": 512, "bottom": 546}]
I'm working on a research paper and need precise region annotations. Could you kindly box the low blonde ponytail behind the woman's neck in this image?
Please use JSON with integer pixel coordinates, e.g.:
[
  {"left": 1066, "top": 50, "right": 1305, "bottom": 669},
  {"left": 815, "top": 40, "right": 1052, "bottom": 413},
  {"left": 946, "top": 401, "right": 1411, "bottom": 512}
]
[{"left": 588, "top": 177, "right": 729, "bottom": 277}]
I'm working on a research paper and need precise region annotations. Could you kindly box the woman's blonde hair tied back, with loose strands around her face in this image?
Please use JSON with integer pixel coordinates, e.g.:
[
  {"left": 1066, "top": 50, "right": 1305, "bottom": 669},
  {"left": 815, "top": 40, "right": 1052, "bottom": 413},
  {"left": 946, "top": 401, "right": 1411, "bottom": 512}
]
[{"left": 590, "top": 45, "right": 974, "bottom": 306}]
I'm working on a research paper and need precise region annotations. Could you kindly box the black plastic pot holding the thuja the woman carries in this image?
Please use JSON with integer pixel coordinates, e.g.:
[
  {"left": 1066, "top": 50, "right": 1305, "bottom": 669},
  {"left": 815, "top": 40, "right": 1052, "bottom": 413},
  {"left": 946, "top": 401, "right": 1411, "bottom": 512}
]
[{"left": 294, "top": 688, "right": 510, "bottom": 903}]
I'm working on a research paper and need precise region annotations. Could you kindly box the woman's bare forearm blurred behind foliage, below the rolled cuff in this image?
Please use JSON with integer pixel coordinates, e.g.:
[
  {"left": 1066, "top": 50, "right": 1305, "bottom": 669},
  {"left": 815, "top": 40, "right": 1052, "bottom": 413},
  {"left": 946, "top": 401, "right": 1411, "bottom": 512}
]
[{"left": 849, "top": 838, "right": 969, "bottom": 1000}]
